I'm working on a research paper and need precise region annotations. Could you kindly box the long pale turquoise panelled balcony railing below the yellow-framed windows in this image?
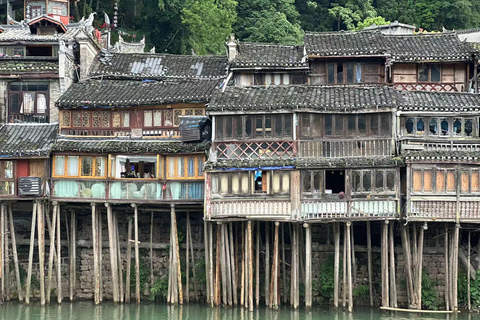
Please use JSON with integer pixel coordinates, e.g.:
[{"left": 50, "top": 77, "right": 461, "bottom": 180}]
[{"left": 53, "top": 179, "right": 204, "bottom": 201}]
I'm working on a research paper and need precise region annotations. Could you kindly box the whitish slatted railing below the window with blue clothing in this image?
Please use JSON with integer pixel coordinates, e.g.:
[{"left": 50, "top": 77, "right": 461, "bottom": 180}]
[{"left": 211, "top": 199, "right": 292, "bottom": 219}]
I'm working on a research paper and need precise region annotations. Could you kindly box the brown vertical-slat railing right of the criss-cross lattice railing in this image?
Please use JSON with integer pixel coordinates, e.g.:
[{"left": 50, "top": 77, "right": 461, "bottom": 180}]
[{"left": 298, "top": 138, "right": 393, "bottom": 158}]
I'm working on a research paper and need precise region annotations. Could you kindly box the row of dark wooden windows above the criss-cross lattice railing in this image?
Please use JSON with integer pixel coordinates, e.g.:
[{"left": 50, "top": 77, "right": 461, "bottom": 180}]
[{"left": 215, "top": 114, "right": 292, "bottom": 141}]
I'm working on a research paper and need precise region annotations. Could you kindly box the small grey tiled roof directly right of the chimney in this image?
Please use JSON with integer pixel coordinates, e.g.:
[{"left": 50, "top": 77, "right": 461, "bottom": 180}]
[{"left": 232, "top": 42, "right": 308, "bottom": 68}]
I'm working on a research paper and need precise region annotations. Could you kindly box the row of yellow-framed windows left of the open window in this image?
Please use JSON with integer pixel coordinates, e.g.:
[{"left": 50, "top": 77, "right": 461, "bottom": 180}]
[{"left": 53, "top": 155, "right": 107, "bottom": 178}]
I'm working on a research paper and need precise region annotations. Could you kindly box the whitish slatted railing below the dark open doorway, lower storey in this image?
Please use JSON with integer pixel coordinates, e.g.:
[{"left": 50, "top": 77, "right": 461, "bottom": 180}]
[{"left": 302, "top": 199, "right": 397, "bottom": 219}]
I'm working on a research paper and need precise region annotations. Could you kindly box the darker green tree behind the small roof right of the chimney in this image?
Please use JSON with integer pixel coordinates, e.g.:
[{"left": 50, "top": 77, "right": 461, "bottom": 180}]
[{"left": 234, "top": 0, "right": 303, "bottom": 43}]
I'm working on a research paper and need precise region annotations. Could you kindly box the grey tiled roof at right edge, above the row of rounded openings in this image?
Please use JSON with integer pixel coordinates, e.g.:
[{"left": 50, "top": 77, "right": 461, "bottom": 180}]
[{"left": 398, "top": 91, "right": 480, "bottom": 112}]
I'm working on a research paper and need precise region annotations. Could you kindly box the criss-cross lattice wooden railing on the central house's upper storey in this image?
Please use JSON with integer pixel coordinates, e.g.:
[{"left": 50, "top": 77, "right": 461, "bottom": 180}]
[{"left": 216, "top": 141, "right": 295, "bottom": 159}]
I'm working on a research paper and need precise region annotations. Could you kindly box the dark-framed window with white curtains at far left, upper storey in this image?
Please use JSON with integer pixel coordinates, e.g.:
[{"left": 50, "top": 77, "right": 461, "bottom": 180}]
[{"left": 9, "top": 82, "right": 49, "bottom": 117}]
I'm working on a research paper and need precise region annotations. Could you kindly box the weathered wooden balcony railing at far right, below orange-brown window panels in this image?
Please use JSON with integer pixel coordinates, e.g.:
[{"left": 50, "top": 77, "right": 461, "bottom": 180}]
[{"left": 408, "top": 196, "right": 480, "bottom": 222}]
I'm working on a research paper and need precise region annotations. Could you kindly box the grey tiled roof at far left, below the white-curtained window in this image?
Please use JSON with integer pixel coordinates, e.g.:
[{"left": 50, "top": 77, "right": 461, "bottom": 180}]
[{"left": 0, "top": 123, "right": 58, "bottom": 158}]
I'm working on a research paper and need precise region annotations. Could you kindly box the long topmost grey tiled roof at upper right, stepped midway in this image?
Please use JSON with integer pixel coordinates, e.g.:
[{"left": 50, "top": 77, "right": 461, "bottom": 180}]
[{"left": 304, "top": 31, "right": 476, "bottom": 62}]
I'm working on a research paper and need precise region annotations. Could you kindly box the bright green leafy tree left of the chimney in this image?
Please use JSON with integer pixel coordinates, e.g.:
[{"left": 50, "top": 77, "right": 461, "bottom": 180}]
[{"left": 182, "top": 0, "right": 237, "bottom": 55}]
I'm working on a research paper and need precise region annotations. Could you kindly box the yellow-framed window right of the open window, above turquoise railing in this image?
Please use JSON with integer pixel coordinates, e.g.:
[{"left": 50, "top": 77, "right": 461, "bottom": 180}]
[{"left": 167, "top": 155, "right": 204, "bottom": 179}]
